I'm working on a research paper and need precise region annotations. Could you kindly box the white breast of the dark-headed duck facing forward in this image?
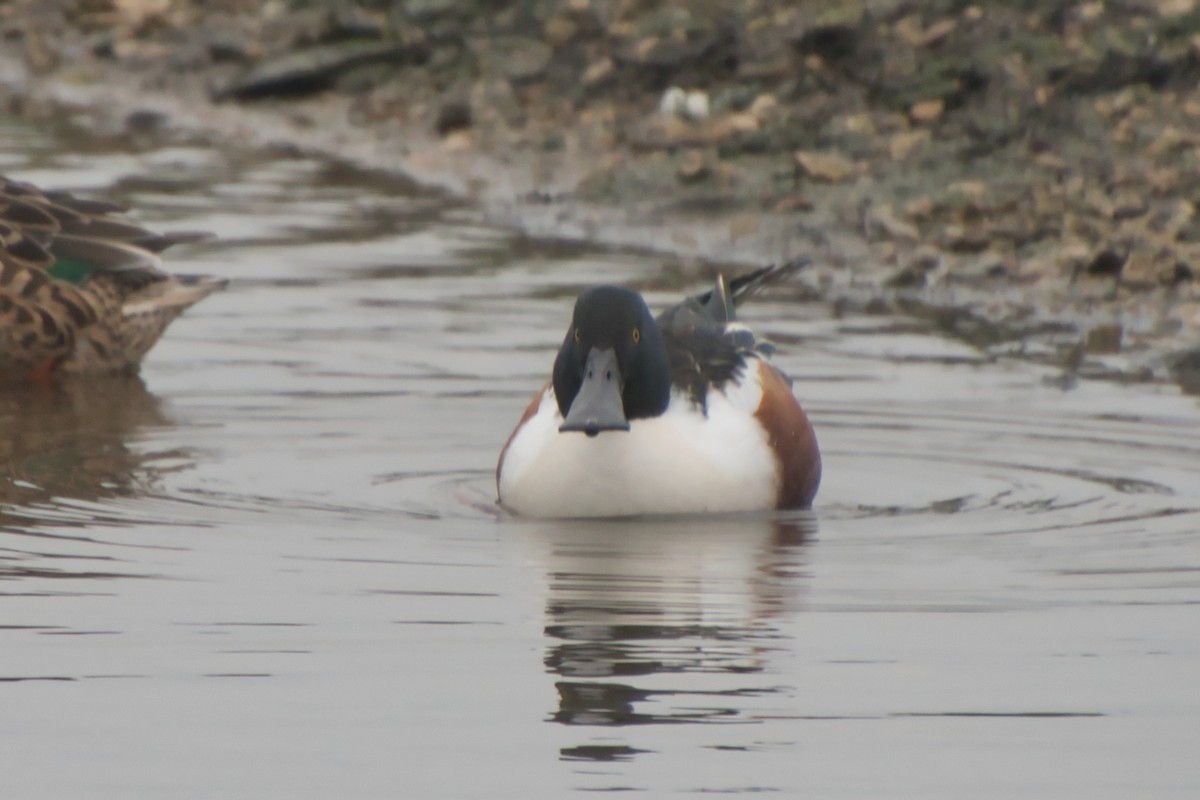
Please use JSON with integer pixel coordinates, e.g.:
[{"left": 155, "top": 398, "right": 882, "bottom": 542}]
[{"left": 499, "top": 368, "right": 779, "bottom": 517}]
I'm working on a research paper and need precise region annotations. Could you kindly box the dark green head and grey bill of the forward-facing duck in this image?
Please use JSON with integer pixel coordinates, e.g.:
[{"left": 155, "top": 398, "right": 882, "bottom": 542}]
[{"left": 554, "top": 285, "right": 671, "bottom": 437}]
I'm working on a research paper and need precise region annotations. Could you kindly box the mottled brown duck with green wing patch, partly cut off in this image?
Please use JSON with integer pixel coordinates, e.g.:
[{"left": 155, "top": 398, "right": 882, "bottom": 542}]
[{"left": 0, "top": 176, "right": 224, "bottom": 384}]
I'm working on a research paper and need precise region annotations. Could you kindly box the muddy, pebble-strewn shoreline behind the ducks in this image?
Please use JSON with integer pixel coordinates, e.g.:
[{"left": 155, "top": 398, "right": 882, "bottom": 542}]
[{"left": 7, "top": 0, "right": 1200, "bottom": 391}]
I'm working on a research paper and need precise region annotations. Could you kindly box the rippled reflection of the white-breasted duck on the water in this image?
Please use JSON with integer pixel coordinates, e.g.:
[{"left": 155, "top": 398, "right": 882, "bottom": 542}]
[{"left": 530, "top": 512, "right": 816, "bottom": 760}]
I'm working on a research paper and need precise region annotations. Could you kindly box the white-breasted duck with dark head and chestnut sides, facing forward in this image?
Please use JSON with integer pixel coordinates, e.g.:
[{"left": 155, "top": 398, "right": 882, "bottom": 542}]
[{"left": 496, "top": 259, "right": 821, "bottom": 517}]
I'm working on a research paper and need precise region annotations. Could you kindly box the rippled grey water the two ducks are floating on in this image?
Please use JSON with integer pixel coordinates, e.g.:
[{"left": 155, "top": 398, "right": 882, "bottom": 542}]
[{"left": 0, "top": 125, "right": 1200, "bottom": 800}]
